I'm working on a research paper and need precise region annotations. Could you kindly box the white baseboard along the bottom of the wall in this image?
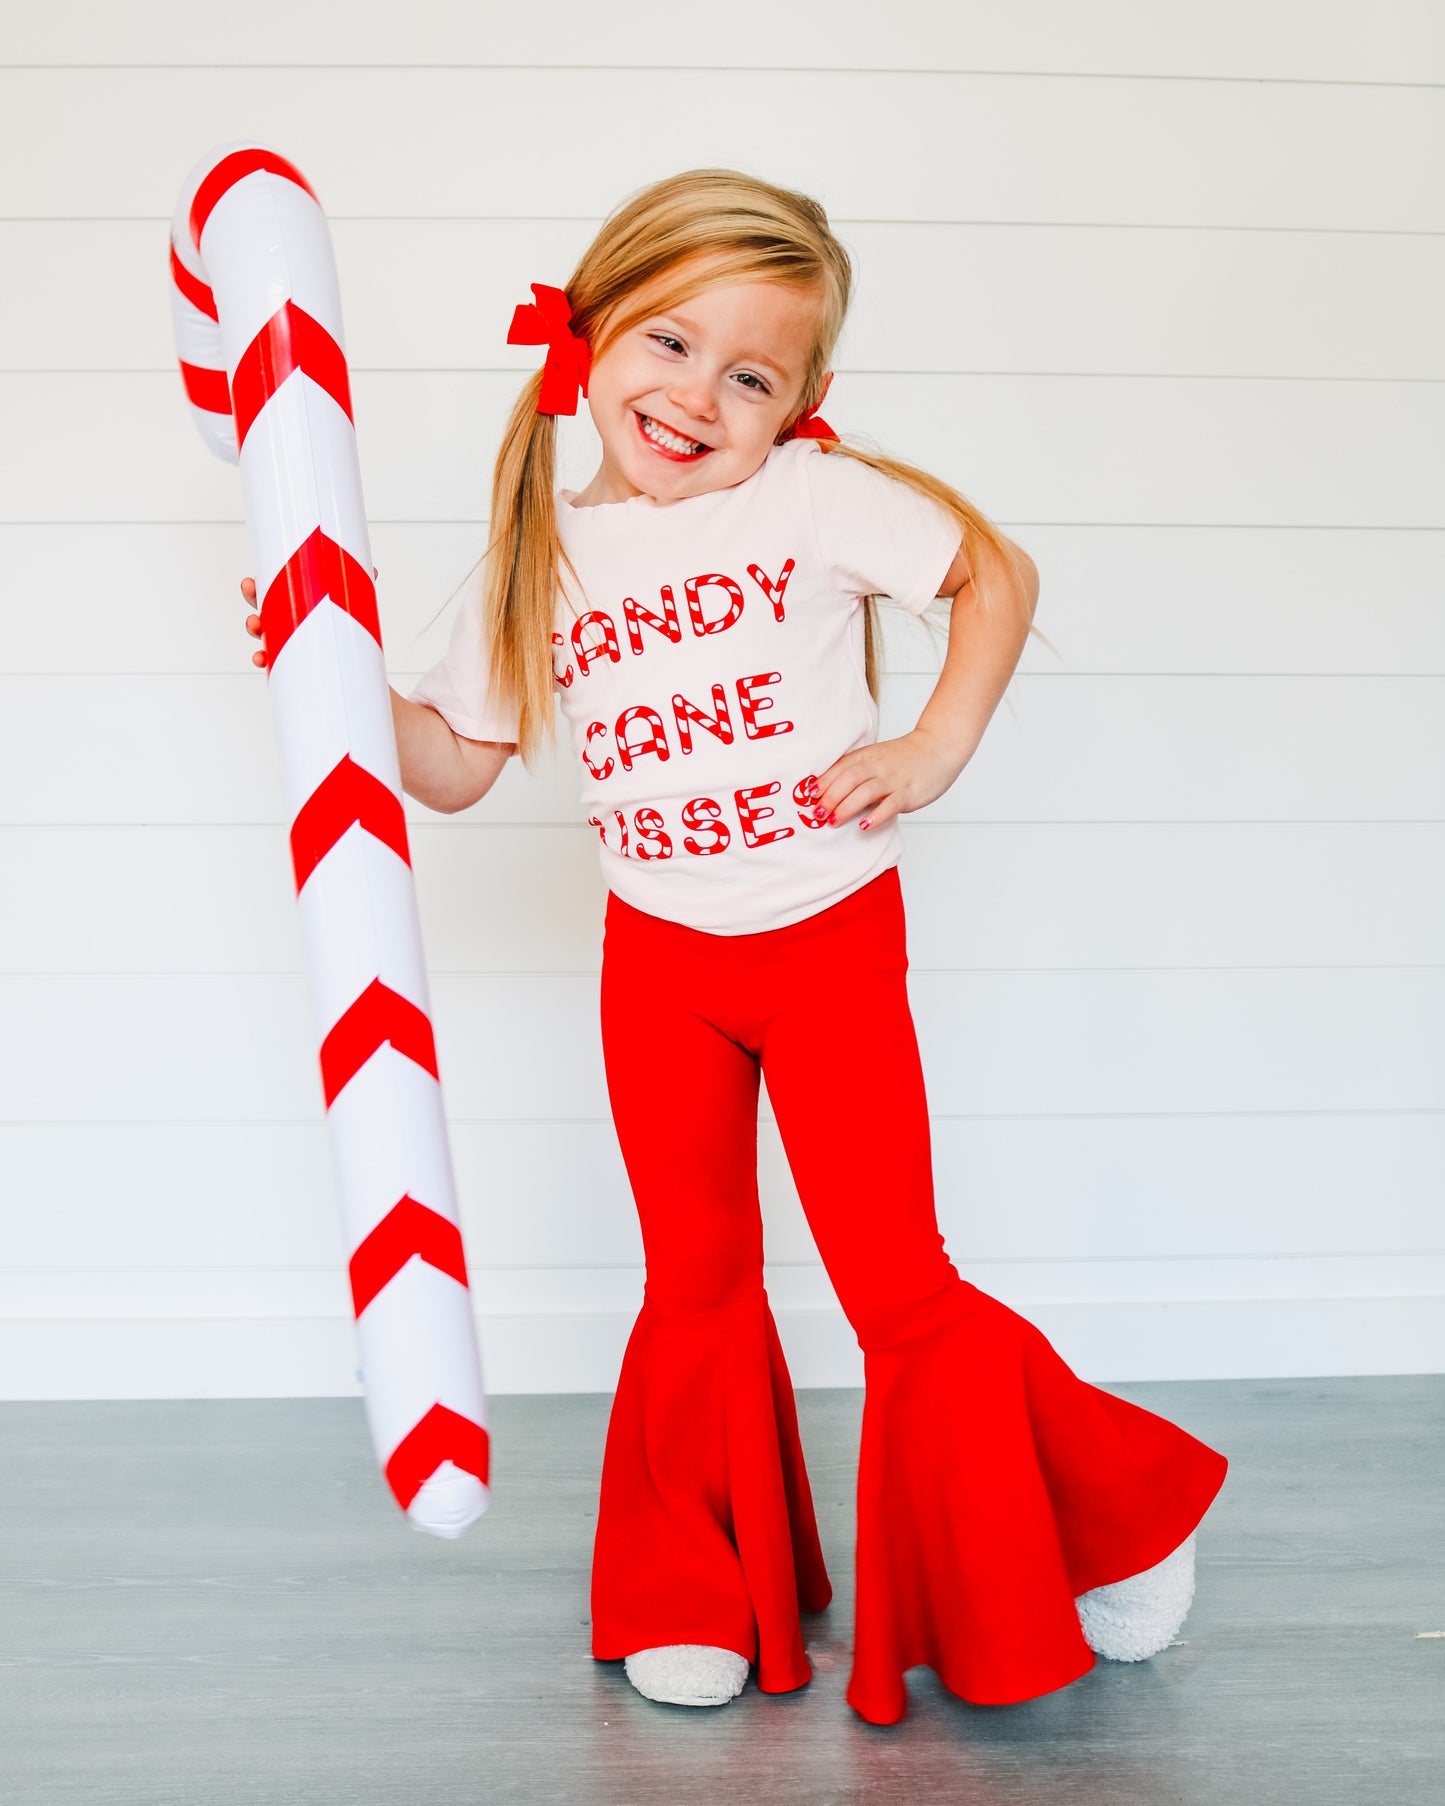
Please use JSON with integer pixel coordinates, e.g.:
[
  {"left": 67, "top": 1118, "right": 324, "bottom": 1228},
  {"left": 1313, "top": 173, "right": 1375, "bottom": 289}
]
[{"left": 0, "top": 1297, "right": 1445, "bottom": 1400}]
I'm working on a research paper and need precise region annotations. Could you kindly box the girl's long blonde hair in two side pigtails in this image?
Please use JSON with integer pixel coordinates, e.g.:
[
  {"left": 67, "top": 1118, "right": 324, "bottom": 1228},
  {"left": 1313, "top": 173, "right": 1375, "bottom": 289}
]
[{"left": 473, "top": 170, "right": 1040, "bottom": 764}]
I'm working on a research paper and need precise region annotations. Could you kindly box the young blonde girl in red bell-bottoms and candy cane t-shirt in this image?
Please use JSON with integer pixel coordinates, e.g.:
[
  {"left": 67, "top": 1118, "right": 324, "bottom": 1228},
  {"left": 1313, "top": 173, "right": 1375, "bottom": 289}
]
[{"left": 247, "top": 170, "right": 1225, "bottom": 1725}]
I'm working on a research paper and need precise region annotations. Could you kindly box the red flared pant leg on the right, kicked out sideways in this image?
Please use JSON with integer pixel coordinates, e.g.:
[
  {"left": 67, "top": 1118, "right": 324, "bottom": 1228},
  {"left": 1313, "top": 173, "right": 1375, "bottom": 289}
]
[{"left": 762, "top": 870, "right": 1226, "bottom": 1723}]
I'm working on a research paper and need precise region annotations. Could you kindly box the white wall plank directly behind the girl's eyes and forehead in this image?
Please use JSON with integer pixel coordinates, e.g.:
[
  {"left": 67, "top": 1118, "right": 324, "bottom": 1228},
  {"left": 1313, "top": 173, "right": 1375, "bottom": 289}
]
[{"left": 0, "top": 219, "right": 1445, "bottom": 383}]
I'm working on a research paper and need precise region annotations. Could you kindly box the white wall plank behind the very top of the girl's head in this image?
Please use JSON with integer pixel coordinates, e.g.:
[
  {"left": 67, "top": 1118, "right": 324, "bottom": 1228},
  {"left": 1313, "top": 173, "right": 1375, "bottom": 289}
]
[{"left": 0, "top": 67, "right": 1445, "bottom": 231}]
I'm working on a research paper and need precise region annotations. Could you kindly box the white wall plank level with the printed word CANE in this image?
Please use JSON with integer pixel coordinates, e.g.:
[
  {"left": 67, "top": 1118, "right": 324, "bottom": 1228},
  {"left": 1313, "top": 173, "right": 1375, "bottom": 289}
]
[{"left": 0, "top": 668, "right": 1445, "bottom": 833}]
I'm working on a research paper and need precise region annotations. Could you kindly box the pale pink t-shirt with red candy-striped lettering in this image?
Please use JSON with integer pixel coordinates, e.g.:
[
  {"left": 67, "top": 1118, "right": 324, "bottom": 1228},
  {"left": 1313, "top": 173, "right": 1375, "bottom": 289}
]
[{"left": 410, "top": 439, "right": 961, "bottom": 934}]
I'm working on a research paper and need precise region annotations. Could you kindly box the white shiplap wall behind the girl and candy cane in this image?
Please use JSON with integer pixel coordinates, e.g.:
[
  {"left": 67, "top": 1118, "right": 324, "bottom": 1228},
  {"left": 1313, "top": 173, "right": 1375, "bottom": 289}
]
[{"left": 0, "top": 0, "right": 1445, "bottom": 1398}]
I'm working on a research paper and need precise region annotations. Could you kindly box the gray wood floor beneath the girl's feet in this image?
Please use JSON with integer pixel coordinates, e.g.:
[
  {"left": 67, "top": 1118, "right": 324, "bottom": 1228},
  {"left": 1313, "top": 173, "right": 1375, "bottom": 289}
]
[{"left": 0, "top": 1376, "right": 1445, "bottom": 1806}]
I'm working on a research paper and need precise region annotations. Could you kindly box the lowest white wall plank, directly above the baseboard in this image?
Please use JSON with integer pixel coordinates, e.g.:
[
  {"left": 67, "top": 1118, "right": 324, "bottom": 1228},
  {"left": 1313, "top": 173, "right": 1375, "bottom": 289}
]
[{"left": 0, "top": 1109, "right": 1445, "bottom": 1271}]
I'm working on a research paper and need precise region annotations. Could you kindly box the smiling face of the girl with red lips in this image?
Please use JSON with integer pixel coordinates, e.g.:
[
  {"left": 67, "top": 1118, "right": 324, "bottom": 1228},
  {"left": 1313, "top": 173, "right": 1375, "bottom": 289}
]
[{"left": 576, "top": 282, "right": 818, "bottom": 507}]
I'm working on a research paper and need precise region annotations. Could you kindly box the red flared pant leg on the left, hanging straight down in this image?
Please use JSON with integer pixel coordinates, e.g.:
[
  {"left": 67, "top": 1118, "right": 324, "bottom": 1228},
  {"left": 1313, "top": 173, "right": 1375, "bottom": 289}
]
[{"left": 592, "top": 898, "right": 831, "bottom": 1692}]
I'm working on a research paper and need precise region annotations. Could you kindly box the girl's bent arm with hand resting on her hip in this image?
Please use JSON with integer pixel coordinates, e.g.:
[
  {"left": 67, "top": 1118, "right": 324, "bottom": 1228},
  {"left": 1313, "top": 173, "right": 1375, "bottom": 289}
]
[{"left": 818, "top": 540, "right": 1039, "bottom": 827}]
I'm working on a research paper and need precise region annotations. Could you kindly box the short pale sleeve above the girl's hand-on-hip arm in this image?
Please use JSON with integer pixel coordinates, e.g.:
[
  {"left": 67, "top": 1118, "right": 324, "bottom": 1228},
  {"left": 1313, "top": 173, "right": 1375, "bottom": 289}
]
[{"left": 804, "top": 450, "right": 963, "bottom": 614}]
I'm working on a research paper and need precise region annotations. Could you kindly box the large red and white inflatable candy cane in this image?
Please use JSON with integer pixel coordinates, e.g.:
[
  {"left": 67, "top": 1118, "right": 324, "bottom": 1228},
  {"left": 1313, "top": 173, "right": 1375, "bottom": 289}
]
[{"left": 170, "top": 144, "right": 489, "bottom": 1537}]
